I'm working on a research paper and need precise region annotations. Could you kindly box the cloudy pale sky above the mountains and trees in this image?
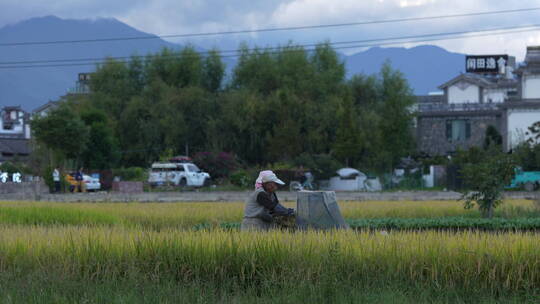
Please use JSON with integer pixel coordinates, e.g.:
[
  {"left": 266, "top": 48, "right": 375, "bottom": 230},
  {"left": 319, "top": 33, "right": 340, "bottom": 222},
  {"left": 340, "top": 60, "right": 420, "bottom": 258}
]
[{"left": 0, "top": 0, "right": 540, "bottom": 60}]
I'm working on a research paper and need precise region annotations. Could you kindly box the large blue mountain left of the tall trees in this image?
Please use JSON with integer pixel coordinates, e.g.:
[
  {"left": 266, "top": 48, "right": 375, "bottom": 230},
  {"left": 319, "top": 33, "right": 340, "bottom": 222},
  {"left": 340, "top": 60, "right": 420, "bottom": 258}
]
[{"left": 0, "top": 16, "right": 179, "bottom": 111}]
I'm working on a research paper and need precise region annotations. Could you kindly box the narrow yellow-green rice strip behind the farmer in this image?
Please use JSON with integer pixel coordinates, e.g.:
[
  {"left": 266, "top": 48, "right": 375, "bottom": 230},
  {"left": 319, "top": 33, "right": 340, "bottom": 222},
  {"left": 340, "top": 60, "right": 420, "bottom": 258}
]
[{"left": 0, "top": 200, "right": 540, "bottom": 229}]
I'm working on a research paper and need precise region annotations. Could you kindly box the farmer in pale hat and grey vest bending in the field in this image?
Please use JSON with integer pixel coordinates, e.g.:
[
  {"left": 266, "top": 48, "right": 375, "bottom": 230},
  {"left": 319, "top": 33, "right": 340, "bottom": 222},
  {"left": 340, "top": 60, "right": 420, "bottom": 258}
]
[{"left": 242, "top": 171, "right": 294, "bottom": 231}]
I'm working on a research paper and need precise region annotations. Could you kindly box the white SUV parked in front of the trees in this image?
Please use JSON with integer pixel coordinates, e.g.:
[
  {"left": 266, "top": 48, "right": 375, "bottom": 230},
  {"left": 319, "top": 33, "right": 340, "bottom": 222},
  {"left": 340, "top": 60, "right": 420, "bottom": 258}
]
[{"left": 148, "top": 163, "right": 210, "bottom": 187}]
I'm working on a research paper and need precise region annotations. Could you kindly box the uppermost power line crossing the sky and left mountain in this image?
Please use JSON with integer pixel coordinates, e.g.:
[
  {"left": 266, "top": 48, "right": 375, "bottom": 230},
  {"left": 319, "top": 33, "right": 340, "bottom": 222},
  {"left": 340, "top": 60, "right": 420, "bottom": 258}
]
[{"left": 0, "top": 7, "right": 540, "bottom": 46}]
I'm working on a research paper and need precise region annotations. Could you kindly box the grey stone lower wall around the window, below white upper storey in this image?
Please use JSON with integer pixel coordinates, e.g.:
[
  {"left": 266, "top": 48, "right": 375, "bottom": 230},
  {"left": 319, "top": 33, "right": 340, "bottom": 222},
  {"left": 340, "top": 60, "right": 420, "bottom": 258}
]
[{"left": 417, "top": 113, "right": 501, "bottom": 155}]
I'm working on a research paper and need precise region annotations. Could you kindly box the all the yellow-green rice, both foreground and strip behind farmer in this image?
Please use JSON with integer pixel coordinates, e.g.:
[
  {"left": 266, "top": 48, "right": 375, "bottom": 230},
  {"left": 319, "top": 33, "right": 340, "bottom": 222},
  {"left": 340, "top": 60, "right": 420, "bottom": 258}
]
[{"left": 0, "top": 200, "right": 540, "bottom": 303}]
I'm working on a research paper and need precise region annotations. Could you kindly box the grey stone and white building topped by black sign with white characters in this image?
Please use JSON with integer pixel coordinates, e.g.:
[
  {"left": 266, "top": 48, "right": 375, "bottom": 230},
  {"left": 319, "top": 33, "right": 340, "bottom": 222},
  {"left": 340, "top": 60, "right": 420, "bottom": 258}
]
[{"left": 417, "top": 48, "right": 540, "bottom": 156}]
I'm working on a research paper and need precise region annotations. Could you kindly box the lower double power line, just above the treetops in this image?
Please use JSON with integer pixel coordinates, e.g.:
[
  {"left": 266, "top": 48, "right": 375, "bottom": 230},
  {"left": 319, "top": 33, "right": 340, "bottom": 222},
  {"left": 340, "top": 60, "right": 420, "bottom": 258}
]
[{"left": 0, "top": 24, "right": 540, "bottom": 69}]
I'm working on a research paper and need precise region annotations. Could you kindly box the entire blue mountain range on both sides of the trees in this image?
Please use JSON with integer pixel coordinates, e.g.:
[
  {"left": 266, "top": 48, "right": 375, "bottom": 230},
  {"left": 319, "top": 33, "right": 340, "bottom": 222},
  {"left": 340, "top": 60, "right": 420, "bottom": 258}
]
[{"left": 0, "top": 16, "right": 464, "bottom": 111}]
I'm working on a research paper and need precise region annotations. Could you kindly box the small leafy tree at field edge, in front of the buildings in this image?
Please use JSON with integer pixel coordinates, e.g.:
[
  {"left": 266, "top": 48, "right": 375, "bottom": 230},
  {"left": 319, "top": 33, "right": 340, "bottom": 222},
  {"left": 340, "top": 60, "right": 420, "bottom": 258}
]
[{"left": 461, "top": 146, "right": 515, "bottom": 218}]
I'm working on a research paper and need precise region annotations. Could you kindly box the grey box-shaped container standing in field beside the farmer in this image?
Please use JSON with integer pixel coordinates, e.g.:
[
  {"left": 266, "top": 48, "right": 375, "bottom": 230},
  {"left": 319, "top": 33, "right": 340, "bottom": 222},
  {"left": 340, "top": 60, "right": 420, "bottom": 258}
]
[{"left": 296, "top": 191, "right": 349, "bottom": 229}]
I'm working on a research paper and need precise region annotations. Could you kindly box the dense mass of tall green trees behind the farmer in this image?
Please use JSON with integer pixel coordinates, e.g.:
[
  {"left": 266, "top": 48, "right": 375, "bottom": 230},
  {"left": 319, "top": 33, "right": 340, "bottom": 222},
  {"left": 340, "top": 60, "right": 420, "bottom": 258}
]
[{"left": 33, "top": 44, "right": 413, "bottom": 175}]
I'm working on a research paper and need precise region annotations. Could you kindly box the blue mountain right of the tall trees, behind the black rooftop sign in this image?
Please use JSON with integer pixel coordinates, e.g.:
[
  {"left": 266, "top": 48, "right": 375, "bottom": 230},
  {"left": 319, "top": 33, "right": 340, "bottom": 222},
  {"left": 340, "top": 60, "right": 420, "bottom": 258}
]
[{"left": 345, "top": 45, "right": 465, "bottom": 95}]
